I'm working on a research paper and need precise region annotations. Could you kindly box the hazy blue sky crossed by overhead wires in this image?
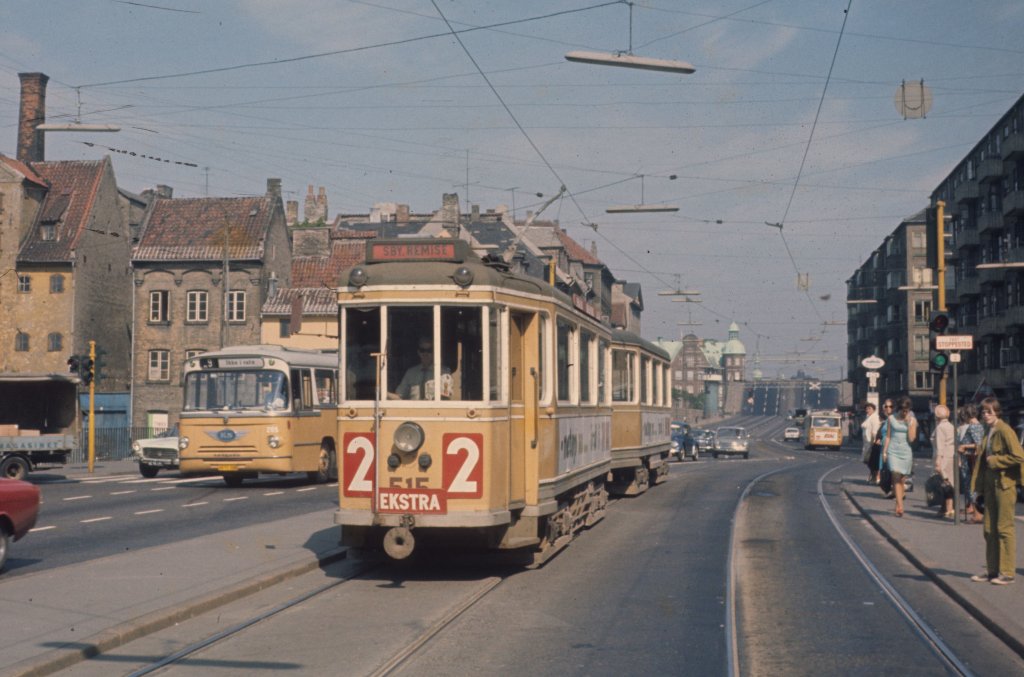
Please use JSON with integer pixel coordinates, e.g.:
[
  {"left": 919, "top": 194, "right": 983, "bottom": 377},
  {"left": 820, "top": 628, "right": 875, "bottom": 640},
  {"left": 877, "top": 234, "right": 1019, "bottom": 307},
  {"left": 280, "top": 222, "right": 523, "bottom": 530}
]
[{"left": 0, "top": 0, "right": 1024, "bottom": 380}]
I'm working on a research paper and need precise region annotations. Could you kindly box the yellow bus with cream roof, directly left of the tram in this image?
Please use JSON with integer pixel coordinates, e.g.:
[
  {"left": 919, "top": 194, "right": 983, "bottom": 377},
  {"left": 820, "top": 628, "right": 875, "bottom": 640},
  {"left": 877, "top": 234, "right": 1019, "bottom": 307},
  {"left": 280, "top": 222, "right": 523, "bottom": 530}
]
[{"left": 178, "top": 345, "right": 338, "bottom": 486}]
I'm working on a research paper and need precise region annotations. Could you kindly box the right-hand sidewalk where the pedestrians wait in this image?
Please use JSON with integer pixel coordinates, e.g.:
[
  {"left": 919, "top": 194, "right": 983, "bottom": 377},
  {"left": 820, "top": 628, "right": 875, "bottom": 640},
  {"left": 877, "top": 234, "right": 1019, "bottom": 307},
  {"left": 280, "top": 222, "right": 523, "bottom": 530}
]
[{"left": 843, "top": 461, "right": 1024, "bottom": 657}]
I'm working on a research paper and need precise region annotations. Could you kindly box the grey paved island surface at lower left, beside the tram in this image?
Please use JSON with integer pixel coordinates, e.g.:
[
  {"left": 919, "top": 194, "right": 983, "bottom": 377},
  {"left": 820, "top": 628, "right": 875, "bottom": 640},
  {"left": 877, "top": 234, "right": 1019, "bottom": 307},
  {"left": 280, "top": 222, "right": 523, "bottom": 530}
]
[{"left": 0, "top": 503, "right": 345, "bottom": 676}]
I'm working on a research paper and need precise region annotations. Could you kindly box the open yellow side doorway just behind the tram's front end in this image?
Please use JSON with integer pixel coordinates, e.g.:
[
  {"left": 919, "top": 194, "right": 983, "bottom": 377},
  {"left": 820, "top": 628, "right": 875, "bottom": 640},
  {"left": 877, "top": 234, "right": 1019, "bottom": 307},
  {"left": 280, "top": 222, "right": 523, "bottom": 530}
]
[{"left": 509, "top": 311, "right": 540, "bottom": 506}]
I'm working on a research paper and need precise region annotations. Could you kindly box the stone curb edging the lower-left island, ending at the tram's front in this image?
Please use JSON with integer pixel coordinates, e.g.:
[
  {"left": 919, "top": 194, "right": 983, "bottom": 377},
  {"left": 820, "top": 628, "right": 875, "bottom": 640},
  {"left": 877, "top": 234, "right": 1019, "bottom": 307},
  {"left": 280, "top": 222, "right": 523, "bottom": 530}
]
[{"left": 3, "top": 546, "right": 348, "bottom": 677}]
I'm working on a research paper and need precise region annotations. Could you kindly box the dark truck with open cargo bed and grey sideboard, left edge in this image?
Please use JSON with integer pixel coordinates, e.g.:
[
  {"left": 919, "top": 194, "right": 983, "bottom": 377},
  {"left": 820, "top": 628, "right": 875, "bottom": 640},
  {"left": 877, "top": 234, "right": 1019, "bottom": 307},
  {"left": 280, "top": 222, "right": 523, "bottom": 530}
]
[{"left": 0, "top": 373, "right": 82, "bottom": 479}]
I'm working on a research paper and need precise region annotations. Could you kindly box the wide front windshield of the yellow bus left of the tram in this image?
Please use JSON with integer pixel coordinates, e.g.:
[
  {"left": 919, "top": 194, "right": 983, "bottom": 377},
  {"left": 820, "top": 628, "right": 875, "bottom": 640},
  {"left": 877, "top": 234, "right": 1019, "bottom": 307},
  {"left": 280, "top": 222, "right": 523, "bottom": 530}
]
[{"left": 184, "top": 370, "right": 289, "bottom": 412}]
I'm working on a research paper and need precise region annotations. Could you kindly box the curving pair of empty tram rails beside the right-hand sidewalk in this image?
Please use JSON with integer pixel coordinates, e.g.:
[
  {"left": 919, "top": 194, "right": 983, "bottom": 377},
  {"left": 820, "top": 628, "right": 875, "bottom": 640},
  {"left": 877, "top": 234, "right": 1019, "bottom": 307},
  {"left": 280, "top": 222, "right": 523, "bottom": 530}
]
[{"left": 725, "top": 448, "right": 974, "bottom": 677}]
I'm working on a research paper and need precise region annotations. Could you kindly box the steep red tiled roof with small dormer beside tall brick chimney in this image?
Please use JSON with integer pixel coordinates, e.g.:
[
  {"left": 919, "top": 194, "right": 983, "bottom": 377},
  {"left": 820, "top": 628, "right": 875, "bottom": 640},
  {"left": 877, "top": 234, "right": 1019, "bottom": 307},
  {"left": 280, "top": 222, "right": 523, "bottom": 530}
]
[{"left": 17, "top": 159, "right": 110, "bottom": 263}]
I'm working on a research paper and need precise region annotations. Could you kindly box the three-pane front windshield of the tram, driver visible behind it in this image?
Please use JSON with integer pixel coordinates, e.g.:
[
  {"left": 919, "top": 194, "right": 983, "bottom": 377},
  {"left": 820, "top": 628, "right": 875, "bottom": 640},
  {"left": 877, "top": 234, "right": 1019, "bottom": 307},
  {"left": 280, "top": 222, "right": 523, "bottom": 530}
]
[{"left": 342, "top": 305, "right": 503, "bottom": 401}]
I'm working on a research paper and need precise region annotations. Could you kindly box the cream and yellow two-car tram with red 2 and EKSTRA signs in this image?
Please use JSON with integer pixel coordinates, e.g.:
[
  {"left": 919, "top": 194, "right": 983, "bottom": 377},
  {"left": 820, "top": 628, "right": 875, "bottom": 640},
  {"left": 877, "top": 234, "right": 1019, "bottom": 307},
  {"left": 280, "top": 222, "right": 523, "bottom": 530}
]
[{"left": 335, "top": 239, "right": 669, "bottom": 563}]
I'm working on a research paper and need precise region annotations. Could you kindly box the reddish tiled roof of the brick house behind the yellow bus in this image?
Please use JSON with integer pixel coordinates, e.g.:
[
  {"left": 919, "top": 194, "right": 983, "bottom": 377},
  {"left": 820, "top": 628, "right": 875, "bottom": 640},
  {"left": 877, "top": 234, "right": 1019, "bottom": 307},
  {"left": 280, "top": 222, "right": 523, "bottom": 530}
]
[{"left": 132, "top": 196, "right": 274, "bottom": 261}]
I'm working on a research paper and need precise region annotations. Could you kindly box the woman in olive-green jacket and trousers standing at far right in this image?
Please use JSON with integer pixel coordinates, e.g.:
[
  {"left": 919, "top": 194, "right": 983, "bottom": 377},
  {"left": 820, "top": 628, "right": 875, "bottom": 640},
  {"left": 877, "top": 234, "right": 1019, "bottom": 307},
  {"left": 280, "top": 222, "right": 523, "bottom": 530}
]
[{"left": 971, "top": 397, "right": 1024, "bottom": 585}]
